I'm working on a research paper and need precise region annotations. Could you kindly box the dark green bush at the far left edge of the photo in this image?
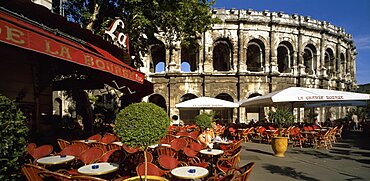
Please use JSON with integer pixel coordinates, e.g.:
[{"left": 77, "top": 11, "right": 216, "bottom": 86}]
[{"left": 0, "top": 95, "right": 28, "bottom": 180}]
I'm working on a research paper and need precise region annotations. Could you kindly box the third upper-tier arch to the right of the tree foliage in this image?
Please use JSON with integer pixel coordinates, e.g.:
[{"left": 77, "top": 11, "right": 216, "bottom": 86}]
[{"left": 277, "top": 41, "right": 293, "bottom": 73}]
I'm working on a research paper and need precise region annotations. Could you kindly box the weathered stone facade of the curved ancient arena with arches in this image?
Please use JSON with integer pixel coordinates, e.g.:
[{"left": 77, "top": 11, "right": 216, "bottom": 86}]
[{"left": 141, "top": 9, "right": 357, "bottom": 122}]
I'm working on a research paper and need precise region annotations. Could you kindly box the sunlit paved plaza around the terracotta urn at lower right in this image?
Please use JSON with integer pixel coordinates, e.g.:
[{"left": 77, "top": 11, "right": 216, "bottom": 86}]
[{"left": 241, "top": 132, "right": 370, "bottom": 181}]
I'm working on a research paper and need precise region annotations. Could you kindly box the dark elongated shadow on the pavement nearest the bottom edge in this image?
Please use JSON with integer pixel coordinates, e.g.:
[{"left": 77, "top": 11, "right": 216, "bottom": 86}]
[{"left": 262, "top": 164, "right": 318, "bottom": 181}]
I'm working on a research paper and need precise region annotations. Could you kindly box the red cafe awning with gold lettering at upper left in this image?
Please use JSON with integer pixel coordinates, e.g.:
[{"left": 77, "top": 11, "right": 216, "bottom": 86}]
[{"left": 0, "top": 11, "right": 144, "bottom": 84}]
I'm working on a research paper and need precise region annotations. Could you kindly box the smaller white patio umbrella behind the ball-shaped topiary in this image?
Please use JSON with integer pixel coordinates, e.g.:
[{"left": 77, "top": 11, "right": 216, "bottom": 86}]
[{"left": 175, "top": 97, "right": 239, "bottom": 109}]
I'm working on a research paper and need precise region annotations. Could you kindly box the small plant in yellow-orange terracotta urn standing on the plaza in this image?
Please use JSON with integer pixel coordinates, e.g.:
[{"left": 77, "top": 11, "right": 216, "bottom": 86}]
[{"left": 268, "top": 107, "right": 294, "bottom": 157}]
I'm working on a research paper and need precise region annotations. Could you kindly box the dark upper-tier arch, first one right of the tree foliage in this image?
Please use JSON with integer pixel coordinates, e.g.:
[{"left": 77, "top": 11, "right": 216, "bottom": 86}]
[{"left": 213, "top": 41, "right": 232, "bottom": 71}]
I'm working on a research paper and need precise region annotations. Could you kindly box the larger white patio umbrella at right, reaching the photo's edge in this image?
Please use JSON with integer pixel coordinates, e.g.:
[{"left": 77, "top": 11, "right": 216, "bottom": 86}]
[{"left": 239, "top": 87, "right": 370, "bottom": 107}]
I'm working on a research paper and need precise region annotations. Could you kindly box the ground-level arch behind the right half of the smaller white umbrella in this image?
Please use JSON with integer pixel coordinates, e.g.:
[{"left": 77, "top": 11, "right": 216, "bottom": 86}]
[{"left": 214, "top": 93, "right": 234, "bottom": 123}]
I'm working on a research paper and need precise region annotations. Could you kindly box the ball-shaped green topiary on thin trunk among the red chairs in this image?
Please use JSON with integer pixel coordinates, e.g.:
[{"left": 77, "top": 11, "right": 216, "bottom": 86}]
[{"left": 114, "top": 102, "right": 170, "bottom": 180}]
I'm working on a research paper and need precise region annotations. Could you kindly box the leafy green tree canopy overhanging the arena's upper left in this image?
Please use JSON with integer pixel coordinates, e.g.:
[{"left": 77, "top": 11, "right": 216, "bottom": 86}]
[{"left": 64, "top": 0, "right": 217, "bottom": 67}]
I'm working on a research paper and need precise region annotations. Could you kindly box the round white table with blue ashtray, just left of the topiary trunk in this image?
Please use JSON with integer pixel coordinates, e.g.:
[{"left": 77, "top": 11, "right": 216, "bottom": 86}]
[{"left": 77, "top": 162, "right": 119, "bottom": 176}]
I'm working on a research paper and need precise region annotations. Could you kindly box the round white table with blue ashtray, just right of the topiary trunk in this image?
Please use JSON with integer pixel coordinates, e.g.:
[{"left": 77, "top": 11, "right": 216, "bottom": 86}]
[{"left": 171, "top": 166, "right": 208, "bottom": 180}]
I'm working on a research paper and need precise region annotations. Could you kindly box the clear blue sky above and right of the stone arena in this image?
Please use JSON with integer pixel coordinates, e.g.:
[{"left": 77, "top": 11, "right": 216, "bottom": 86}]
[{"left": 214, "top": 0, "right": 370, "bottom": 84}]
